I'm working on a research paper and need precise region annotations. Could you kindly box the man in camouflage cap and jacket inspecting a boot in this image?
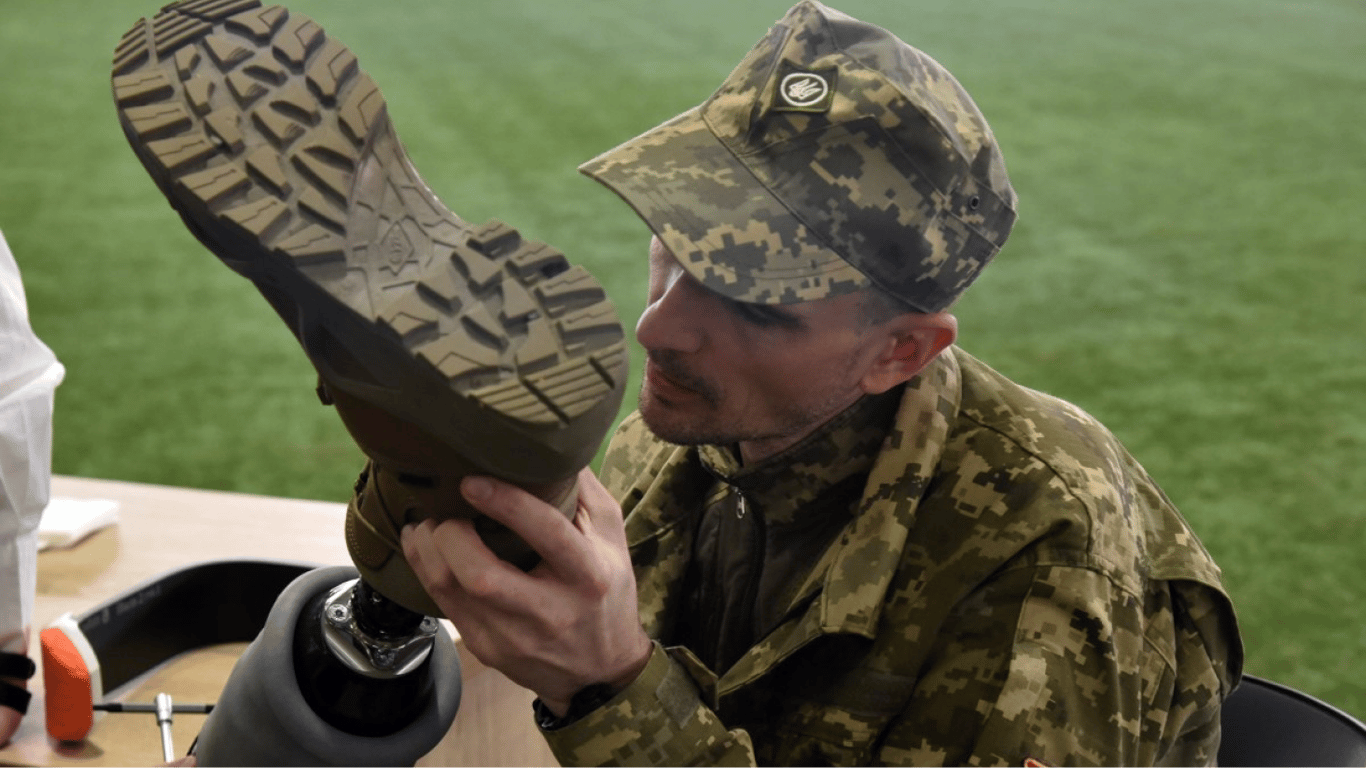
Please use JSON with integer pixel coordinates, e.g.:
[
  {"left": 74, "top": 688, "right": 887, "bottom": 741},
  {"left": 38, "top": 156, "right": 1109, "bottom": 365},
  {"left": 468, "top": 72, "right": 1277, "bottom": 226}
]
[{"left": 403, "top": 0, "right": 1242, "bottom": 767}]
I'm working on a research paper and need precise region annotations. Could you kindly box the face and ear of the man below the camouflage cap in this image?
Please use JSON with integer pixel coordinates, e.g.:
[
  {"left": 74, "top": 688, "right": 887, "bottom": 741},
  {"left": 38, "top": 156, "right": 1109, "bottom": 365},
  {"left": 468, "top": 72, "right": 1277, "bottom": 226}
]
[{"left": 635, "top": 238, "right": 880, "bottom": 461}]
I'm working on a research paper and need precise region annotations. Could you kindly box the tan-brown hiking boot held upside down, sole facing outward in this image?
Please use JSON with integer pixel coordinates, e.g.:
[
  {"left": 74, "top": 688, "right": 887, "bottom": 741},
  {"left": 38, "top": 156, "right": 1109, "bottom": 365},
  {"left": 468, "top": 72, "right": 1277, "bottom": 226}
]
[{"left": 112, "top": 0, "right": 627, "bottom": 615}]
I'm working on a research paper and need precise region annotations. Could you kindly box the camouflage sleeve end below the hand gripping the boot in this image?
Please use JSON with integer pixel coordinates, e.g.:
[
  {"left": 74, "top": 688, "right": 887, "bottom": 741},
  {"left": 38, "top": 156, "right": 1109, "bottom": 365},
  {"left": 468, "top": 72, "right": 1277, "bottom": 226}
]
[{"left": 541, "top": 644, "right": 754, "bottom": 768}]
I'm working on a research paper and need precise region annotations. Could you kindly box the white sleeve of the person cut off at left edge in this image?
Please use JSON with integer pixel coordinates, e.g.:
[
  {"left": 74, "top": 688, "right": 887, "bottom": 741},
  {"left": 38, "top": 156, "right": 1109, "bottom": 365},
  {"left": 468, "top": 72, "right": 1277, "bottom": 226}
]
[{"left": 0, "top": 234, "right": 66, "bottom": 652}]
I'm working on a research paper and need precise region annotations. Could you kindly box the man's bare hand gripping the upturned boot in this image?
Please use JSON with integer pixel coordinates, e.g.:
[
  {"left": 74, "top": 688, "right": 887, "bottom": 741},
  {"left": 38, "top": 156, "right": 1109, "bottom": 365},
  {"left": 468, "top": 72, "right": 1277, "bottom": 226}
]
[{"left": 402, "top": 469, "right": 652, "bottom": 716}]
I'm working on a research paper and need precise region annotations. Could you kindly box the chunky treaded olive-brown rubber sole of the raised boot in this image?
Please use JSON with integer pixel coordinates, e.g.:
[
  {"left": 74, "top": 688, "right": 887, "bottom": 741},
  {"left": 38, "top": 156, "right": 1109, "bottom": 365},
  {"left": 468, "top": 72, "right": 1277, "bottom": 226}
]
[{"left": 112, "top": 0, "right": 627, "bottom": 428}]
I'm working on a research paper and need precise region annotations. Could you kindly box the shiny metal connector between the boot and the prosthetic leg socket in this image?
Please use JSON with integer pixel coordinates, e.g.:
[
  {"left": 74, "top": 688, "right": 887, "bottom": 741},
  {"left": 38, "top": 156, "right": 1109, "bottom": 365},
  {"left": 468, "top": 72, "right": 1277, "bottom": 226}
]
[{"left": 322, "top": 579, "right": 437, "bottom": 679}]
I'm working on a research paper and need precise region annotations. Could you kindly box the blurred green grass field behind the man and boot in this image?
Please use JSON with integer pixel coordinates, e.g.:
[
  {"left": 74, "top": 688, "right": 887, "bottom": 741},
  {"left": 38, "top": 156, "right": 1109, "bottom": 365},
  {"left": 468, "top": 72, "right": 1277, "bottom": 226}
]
[{"left": 0, "top": 0, "right": 1366, "bottom": 716}]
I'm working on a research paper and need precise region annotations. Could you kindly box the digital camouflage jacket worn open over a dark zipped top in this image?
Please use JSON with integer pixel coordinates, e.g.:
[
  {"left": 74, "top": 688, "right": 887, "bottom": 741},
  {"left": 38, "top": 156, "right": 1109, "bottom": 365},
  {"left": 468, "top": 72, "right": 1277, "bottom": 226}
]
[{"left": 545, "top": 348, "right": 1242, "bottom": 767}]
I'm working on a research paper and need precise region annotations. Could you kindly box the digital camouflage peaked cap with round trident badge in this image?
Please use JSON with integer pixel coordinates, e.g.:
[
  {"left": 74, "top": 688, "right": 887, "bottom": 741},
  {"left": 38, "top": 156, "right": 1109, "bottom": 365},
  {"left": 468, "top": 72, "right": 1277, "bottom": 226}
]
[{"left": 579, "top": 0, "right": 1015, "bottom": 312}]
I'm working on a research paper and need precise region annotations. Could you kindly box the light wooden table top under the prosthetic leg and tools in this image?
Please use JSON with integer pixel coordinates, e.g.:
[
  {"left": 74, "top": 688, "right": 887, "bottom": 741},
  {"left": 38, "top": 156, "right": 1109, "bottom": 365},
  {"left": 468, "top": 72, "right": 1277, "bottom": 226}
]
[{"left": 0, "top": 476, "right": 556, "bottom": 767}]
